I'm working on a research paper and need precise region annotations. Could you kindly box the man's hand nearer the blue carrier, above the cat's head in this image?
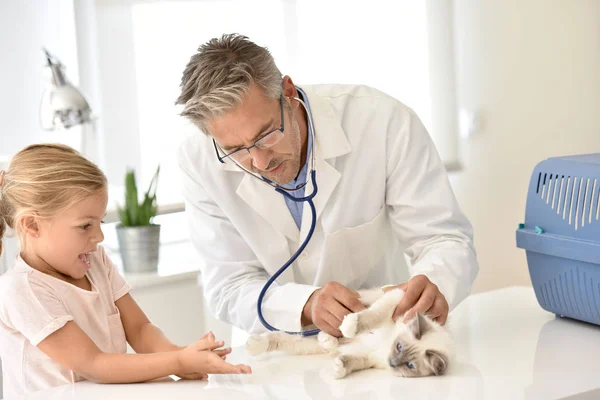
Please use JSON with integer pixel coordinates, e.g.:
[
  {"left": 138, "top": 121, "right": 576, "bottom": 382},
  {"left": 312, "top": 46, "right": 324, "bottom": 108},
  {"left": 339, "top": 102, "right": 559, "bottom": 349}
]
[{"left": 384, "top": 275, "right": 449, "bottom": 325}]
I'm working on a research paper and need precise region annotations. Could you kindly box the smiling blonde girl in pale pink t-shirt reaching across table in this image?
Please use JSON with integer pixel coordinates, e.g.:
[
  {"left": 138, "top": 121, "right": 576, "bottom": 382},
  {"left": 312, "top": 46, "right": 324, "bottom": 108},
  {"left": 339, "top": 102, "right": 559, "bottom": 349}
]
[{"left": 0, "top": 144, "right": 251, "bottom": 396}]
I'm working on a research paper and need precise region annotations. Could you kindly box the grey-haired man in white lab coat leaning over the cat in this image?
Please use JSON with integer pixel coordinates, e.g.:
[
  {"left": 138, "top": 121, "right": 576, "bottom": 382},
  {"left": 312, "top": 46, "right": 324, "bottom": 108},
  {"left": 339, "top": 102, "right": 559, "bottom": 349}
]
[{"left": 177, "top": 34, "right": 478, "bottom": 336}]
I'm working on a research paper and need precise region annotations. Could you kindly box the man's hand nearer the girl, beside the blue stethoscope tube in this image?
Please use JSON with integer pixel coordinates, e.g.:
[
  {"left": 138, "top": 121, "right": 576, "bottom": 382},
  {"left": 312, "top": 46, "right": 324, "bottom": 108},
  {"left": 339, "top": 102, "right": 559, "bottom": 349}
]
[{"left": 302, "top": 282, "right": 365, "bottom": 337}]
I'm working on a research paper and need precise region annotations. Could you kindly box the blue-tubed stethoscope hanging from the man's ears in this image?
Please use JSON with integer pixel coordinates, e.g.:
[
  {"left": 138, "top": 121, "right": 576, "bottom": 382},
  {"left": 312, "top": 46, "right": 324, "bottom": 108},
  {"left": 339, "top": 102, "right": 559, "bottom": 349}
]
[{"left": 224, "top": 88, "right": 320, "bottom": 336}]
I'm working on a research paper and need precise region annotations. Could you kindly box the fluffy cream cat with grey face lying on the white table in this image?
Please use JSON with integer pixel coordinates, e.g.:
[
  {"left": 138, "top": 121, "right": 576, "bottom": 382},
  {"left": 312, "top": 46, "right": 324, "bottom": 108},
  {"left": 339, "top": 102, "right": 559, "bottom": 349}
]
[{"left": 246, "top": 289, "right": 454, "bottom": 379}]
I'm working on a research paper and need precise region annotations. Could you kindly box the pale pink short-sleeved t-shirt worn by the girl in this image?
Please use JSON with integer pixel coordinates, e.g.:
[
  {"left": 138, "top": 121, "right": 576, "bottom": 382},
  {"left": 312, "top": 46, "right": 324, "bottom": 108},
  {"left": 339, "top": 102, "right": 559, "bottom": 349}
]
[{"left": 0, "top": 246, "right": 131, "bottom": 397}]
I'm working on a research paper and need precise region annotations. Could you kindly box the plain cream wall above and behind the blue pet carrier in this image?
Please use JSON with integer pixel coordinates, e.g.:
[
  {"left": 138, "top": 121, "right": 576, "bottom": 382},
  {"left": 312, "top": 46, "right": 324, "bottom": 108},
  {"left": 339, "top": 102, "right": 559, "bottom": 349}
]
[{"left": 452, "top": 0, "right": 600, "bottom": 291}]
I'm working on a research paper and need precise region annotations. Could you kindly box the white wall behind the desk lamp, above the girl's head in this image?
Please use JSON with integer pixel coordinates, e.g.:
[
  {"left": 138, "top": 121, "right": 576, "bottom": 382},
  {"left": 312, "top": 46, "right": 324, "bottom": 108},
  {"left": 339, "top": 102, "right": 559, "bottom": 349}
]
[{"left": 0, "top": 0, "right": 79, "bottom": 156}]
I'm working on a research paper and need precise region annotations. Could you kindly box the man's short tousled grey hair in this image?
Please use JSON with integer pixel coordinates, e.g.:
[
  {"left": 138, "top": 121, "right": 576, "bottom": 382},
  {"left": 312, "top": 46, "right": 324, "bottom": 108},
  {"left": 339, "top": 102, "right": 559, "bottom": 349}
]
[{"left": 175, "top": 33, "right": 282, "bottom": 133}]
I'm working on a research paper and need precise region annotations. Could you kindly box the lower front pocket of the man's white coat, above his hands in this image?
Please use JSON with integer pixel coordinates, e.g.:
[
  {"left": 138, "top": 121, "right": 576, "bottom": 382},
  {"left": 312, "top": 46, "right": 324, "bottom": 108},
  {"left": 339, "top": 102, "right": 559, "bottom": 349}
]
[{"left": 318, "top": 206, "right": 387, "bottom": 286}]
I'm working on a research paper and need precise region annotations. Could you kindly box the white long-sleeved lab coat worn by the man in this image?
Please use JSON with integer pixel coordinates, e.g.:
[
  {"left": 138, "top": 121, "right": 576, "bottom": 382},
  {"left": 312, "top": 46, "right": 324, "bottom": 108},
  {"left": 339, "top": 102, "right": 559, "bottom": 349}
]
[{"left": 179, "top": 85, "right": 478, "bottom": 333}]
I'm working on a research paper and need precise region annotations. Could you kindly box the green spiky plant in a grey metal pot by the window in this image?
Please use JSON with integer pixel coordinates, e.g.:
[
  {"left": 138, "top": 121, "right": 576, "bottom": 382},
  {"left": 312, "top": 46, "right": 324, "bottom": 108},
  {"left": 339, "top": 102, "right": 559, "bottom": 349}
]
[{"left": 117, "top": 166, "right": 160, "bottom": 273}]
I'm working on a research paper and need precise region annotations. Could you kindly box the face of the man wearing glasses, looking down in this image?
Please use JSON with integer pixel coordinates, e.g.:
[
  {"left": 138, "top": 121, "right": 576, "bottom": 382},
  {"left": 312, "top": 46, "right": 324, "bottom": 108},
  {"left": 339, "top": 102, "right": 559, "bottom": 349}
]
[{"left": 208, "top": 85, "right": 302, "bottom": 184}]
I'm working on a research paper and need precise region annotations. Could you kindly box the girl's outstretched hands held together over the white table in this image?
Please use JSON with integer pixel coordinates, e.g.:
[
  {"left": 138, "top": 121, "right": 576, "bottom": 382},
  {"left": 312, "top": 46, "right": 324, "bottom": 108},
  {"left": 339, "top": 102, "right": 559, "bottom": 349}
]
[{"left": 177, "top": 332, "right": 252, "bottom": 379}]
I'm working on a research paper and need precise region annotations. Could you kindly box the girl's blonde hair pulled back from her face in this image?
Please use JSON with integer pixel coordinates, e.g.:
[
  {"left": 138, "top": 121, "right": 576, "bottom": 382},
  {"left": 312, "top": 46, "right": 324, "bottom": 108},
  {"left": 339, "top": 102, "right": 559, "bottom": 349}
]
[{"left": 0, "top": 144, "right": 108, "bottom": 254}]
